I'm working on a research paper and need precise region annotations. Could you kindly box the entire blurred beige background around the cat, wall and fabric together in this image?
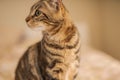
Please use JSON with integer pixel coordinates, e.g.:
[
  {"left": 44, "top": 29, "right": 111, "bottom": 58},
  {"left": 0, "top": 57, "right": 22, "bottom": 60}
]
[{"left": 0, "top": 0, "right": 120, "bottom": 80}]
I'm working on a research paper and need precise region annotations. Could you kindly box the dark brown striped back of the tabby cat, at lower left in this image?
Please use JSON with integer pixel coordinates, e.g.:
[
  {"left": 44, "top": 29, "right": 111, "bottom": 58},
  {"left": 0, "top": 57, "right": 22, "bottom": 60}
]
[{"left": 15, "top": 42, "right": 41, "bottom": 80}]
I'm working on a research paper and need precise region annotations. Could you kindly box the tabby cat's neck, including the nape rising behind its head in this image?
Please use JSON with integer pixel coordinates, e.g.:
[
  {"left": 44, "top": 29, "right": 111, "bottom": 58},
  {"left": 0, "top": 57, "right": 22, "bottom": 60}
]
[{"left": 43, "top": 13, "right": 78, "bottom": 43}]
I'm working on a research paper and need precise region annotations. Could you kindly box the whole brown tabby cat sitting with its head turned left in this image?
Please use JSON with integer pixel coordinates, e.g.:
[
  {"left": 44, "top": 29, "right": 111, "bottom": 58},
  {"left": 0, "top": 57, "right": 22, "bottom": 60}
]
[{"left": 15, "top": 0, "right": 80, "bottom": 80}]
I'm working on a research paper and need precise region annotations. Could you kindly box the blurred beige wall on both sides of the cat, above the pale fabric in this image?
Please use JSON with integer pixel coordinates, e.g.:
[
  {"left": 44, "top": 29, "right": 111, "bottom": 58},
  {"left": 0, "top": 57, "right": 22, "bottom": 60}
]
[{"left": 0, "top": 0, "right": 120, "bottom": 60}]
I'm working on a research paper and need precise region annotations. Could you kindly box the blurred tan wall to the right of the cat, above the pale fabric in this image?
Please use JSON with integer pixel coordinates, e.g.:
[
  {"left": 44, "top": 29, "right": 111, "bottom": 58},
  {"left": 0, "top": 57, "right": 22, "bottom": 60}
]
[{"left": 65, "top": 0, "right": 120, "bottom": 60}]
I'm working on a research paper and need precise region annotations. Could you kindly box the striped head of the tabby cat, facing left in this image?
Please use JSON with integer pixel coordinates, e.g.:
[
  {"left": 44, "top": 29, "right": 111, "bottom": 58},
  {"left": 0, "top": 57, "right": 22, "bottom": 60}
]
[{"left": 26, "top": 0, "right": 65, "bottom": 30}]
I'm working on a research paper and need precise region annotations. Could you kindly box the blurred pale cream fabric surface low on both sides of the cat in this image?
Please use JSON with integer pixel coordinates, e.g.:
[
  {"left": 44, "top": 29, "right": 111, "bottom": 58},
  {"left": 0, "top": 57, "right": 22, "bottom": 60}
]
[{"left": 0, "top": 45, "right": 120, "bottom": 80}]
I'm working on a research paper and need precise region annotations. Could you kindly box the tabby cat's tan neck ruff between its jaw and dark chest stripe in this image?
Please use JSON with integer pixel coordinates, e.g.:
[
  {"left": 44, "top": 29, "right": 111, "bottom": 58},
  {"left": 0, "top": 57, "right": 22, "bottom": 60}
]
[{"left": 43, "top": 21, "right": 78, "bottom": 44}]
